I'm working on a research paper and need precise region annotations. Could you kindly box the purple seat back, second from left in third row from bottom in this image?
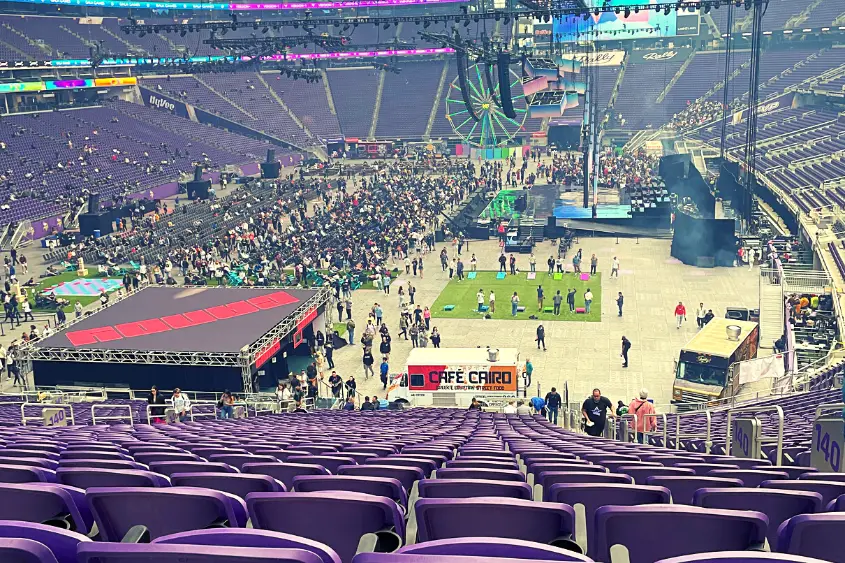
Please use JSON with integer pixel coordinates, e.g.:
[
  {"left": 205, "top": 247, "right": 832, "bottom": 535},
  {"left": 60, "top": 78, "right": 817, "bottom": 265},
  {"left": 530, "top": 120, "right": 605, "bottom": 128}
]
[{"left": 85, "top": 487, "right": 246, "bottom": 541}]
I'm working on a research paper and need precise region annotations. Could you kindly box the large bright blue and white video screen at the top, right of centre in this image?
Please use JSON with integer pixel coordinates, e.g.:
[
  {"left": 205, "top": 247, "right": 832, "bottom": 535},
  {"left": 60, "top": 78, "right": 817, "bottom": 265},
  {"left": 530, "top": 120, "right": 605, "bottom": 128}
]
[{"left": 554, "top": 0, "right": 677, "bottom": 41}]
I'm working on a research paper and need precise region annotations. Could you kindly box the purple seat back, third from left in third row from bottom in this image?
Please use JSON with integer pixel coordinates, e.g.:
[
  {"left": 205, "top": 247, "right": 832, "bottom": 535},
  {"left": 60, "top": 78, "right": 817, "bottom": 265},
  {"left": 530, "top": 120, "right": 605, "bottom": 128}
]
[{"left": 246, "top": 491, "right": 405, "bottom": 563}]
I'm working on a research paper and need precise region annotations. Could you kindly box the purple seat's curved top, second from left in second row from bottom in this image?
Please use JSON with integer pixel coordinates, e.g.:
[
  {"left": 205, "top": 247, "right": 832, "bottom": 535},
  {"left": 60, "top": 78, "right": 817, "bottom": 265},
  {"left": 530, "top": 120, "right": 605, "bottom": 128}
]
[{"left": 153, "top": 528, "right": 341, "bottom": 563}]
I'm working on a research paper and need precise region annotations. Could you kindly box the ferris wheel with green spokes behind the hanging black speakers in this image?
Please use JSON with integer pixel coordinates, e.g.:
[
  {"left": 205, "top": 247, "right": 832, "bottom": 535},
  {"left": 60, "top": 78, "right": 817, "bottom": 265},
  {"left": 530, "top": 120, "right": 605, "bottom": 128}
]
[{"left": 446, "top": 64, "right": 528, "bottom": 148}]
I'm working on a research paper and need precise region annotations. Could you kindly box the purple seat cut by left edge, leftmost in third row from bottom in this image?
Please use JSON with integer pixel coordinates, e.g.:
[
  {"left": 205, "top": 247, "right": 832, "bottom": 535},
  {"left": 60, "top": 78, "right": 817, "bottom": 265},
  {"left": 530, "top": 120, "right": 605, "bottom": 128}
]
[{"left": 0, "top": 483, "right": 92, "bottom": 534}]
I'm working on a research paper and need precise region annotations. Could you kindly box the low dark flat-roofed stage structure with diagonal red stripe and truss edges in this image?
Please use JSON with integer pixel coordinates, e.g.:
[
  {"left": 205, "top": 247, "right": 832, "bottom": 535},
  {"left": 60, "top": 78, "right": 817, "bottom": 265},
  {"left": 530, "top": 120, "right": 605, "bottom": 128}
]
[{"left": 21, "top": 287, "right": 330, "bottom": 392}]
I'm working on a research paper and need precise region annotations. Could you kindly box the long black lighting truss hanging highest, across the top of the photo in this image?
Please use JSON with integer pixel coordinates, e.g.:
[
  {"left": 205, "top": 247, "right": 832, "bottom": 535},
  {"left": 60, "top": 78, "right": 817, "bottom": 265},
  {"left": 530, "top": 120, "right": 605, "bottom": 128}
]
[{"left": 120, "top": 0, "right": 742, "bottom": 34}]
